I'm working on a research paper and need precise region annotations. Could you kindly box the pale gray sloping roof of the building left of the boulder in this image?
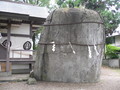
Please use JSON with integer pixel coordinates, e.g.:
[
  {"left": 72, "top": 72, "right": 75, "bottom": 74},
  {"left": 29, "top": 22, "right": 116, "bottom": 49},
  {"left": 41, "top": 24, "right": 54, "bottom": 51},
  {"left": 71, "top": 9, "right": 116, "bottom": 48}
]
[{"left": 0, "top": 0, "right": 48, "bottom": 18}]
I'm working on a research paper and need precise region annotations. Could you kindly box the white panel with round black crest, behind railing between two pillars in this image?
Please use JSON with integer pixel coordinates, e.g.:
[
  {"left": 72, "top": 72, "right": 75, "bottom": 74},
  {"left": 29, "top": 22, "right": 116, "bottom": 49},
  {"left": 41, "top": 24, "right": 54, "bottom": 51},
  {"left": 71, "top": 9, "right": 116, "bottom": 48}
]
[{"left": 10, "top": 36, "right": 33, "bottom": 58}]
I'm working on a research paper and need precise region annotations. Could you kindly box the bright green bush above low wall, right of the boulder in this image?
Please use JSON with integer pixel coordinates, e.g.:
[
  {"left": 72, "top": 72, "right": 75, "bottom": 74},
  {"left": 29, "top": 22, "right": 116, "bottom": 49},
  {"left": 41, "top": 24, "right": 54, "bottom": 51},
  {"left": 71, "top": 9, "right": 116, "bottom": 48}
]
[{"left": 105, "top": 44, "right": 120, "bottom": 59}]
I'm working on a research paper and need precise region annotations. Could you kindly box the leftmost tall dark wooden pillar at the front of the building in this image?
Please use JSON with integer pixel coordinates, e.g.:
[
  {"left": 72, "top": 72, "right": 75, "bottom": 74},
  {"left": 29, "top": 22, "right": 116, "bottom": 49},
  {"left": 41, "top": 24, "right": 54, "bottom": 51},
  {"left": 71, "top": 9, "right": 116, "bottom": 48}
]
[{"left": 6, "top": 21, "right": 11, "bottom": 72}]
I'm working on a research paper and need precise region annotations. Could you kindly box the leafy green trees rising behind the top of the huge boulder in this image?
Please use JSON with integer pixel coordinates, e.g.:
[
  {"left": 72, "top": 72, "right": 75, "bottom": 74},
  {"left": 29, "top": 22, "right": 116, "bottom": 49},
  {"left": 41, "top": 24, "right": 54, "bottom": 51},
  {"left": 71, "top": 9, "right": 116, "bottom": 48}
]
[{"left": 56, "top": 0, "right": 120, "bottom": 36}]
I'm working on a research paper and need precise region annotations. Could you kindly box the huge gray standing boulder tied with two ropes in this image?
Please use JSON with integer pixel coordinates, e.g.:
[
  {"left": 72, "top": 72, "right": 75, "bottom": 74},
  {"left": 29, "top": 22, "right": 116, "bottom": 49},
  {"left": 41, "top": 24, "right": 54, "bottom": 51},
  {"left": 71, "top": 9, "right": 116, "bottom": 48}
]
[{"left": 34, "top": 8, "right": 104, "bottom": 82}]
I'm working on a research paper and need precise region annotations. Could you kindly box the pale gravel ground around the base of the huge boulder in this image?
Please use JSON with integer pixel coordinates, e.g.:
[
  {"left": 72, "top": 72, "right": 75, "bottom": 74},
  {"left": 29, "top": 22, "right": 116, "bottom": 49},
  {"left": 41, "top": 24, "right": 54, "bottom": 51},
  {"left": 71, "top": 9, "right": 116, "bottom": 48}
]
[{"left": 0, "top": 67, "right": 120, "bottom": 90}]
